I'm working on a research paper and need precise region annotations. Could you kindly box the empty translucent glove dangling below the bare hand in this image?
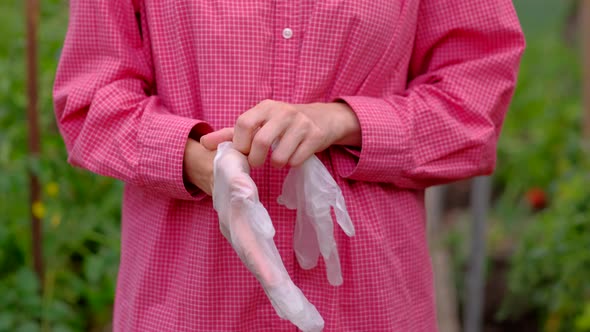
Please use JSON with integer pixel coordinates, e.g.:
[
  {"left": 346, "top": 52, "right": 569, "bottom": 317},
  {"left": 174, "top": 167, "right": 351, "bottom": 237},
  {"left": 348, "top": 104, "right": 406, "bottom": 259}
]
[{"left": 278, "top": 156, "right": 354, "bottom": 286}]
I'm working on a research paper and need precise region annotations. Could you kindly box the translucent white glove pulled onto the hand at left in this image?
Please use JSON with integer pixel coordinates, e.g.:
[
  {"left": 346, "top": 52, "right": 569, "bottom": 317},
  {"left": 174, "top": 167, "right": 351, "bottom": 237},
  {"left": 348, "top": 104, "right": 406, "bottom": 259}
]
[{"left": 213, "top": 142, "right": 324, "bottom": 332}]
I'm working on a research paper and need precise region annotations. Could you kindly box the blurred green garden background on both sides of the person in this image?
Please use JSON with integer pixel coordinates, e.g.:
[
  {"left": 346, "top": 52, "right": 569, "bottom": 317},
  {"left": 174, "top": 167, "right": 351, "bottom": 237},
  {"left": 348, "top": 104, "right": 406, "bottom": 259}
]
[{"left": 0, "top": 0, "right": 590, "bottom": 332}]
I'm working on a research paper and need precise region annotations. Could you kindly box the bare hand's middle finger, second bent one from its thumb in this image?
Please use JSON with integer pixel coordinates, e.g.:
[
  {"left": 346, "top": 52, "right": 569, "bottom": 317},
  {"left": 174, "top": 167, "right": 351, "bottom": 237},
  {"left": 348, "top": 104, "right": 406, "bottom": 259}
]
[{"left": 248, "top": 116, "right": 291, "bottom": 167}]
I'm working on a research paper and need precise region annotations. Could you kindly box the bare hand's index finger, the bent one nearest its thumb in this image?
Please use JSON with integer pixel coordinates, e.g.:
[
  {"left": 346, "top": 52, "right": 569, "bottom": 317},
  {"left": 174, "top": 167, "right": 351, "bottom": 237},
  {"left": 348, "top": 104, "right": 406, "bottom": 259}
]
[{"left": 233, "top": 101, "right": 272, "bottom": 155}]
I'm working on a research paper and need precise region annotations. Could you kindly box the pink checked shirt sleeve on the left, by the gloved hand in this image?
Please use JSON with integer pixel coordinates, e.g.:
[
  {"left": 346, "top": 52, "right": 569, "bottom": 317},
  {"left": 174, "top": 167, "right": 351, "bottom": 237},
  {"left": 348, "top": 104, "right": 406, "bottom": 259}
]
[{"left": 54, "top": 0, "right": 211, "bottom": 199}]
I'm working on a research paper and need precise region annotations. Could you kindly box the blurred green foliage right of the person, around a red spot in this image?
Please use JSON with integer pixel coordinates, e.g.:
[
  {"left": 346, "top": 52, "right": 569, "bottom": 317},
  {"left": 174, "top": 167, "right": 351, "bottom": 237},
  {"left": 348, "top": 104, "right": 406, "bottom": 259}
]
[{"left": 495, "top": 20, "right": 590, "bottom": 332}]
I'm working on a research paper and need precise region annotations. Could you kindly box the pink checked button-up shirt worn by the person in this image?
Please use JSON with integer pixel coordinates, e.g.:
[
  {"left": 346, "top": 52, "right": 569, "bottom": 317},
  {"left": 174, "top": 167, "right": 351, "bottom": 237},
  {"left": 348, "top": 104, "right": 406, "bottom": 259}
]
[{"left": 54, "top": 0, "right": 524, "bottom": 332}]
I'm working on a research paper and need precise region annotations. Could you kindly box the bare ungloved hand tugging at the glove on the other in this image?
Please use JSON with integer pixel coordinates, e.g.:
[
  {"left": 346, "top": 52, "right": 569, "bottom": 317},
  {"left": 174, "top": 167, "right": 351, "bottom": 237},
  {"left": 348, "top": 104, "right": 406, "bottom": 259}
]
[{"left": 201, "top": 100, "right": 361, "bottom": 168}]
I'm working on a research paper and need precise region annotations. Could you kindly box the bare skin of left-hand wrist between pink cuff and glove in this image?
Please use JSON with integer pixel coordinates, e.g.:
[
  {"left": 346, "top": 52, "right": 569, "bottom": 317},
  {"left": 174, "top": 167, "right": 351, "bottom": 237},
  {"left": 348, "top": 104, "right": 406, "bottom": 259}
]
[{"left": 183, "top": 138, "right": 217, "bottom": 196}]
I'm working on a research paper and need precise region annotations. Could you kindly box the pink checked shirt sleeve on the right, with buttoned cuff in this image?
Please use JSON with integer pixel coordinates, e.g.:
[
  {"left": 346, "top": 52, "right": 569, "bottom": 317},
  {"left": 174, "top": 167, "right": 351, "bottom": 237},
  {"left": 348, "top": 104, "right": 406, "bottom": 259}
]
[{"left": 330, "top": 0, "right": 525, "bottom": 189}]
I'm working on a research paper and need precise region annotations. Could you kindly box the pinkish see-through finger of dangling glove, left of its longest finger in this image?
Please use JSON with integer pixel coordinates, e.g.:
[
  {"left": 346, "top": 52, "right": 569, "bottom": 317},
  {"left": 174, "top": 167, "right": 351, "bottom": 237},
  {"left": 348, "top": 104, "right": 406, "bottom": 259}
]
[{"left": 293, "top": 209, "right": 320, "bottom": 270}]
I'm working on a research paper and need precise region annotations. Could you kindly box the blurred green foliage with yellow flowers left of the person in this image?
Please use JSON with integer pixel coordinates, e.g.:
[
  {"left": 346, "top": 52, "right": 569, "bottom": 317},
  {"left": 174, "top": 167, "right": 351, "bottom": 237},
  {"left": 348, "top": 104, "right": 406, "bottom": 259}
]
[{"left": 0, "top": 0, "right": 121, "bottom": 332}]
